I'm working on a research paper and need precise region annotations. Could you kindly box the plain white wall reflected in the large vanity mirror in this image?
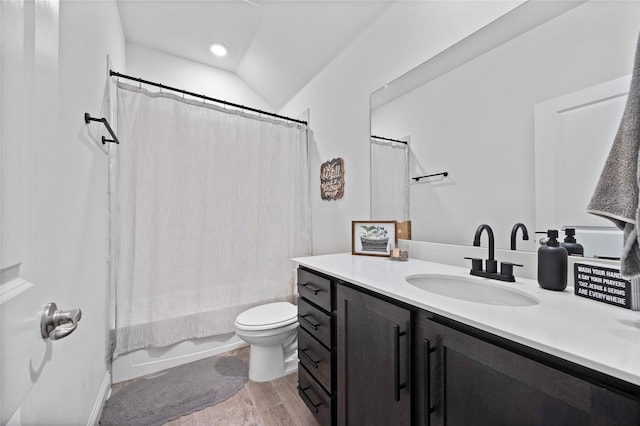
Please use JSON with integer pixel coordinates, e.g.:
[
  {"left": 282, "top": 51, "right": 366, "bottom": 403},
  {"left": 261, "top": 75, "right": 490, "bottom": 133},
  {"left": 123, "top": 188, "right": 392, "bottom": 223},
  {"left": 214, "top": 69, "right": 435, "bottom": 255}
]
[{"left": 373, "top": 2, "right": 640, "bottom": 250}]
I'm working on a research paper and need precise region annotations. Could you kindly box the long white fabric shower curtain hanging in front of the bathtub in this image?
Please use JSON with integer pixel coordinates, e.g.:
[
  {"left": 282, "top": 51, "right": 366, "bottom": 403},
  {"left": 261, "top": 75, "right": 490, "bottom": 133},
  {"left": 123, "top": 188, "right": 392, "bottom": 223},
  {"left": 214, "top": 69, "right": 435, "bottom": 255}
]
[{"left": 110, "top": 83, "right": 311, "bottom": 355}]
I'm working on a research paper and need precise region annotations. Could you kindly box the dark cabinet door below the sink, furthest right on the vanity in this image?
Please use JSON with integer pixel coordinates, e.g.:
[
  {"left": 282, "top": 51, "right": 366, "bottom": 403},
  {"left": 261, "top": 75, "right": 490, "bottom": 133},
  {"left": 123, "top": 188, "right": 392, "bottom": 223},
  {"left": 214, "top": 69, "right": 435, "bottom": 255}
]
[{"left": 415, "top": 315, "right": 640, "bottom": 426}]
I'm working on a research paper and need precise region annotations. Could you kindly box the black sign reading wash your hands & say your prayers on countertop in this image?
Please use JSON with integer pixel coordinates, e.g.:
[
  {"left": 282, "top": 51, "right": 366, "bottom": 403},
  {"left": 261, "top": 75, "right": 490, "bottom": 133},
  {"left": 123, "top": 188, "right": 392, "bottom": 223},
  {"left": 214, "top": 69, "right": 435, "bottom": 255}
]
[{"left": 574, "top": 263, "right": 631, "bottom": 309}]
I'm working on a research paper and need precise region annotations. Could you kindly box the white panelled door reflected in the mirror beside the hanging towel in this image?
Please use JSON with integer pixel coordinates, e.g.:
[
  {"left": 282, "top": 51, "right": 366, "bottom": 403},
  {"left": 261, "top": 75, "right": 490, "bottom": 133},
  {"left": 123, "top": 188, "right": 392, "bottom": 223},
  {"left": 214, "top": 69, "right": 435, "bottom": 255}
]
[{"left": 535, "top": 75, "right": 631, "bottom": 257}]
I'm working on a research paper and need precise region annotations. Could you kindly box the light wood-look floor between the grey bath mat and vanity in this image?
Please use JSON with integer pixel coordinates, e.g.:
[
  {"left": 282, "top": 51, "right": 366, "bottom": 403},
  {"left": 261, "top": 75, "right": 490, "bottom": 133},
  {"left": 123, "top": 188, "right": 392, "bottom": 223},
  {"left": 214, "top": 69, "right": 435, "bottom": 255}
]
[{"left": 111, "top": 347, "right": 318, "bottom": 426}]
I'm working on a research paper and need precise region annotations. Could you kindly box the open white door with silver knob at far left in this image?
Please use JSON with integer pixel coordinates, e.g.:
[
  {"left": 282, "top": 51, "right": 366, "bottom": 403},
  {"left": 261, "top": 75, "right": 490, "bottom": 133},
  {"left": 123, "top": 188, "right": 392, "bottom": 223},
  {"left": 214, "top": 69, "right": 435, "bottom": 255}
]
[{"left": 0, "top": 2, "right": 65, "bottom": 424}]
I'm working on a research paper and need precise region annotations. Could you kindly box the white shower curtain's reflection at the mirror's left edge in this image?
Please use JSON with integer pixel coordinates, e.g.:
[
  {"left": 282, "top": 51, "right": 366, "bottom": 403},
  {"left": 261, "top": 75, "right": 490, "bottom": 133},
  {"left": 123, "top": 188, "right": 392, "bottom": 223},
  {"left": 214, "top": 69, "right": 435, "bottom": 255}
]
[{"left": 371, "top": 138, "right": 409, "bottom": 222}]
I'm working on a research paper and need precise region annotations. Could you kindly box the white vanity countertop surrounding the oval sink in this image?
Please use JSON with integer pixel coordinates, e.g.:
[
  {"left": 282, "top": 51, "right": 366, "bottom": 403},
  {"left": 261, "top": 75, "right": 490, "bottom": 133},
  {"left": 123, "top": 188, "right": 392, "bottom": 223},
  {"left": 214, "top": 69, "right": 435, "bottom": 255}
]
[{"left": 293, "top": 253, "right": 640, "bottom": 386}]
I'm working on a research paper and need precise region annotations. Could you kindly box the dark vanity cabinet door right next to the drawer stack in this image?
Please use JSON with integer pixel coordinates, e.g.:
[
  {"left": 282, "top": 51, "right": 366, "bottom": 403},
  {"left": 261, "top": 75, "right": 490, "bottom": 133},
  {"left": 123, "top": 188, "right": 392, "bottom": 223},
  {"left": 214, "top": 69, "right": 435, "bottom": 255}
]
[{"left": 336, "top": 285, "right": 411, "bottom": 425}]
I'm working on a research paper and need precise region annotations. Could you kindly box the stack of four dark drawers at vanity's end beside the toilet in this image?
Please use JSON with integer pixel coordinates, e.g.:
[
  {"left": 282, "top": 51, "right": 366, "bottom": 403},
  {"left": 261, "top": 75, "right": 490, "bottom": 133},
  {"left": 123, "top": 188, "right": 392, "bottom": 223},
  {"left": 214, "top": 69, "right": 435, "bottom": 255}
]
[{"left": 298, "top": 267, "right": 336, "bottom": 426}]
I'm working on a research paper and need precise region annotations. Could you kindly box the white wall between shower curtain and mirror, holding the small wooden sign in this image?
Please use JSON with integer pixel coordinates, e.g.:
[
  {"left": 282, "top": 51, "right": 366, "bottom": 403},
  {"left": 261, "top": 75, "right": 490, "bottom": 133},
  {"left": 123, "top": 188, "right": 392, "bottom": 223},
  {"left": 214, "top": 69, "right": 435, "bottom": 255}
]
[{"left": 281, "top": 2, "right": 520, "bottom": 254}]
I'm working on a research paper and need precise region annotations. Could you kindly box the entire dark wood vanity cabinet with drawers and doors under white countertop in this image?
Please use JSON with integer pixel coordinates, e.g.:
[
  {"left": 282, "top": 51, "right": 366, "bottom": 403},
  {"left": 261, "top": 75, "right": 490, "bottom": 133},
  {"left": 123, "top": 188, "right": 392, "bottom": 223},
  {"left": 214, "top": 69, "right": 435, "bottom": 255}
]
[{"left": 298, "top": 267, "right": 640, "bottom": 426}]
